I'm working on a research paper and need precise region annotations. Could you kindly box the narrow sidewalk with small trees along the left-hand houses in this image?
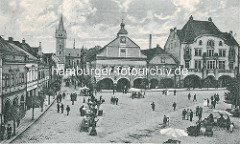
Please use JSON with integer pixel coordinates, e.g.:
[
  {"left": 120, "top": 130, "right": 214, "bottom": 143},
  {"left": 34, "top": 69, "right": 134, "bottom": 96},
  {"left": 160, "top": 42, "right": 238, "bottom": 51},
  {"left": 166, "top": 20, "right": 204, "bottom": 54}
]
[{"left": 1, "top": 96, "right": 55, "bottom": 143}]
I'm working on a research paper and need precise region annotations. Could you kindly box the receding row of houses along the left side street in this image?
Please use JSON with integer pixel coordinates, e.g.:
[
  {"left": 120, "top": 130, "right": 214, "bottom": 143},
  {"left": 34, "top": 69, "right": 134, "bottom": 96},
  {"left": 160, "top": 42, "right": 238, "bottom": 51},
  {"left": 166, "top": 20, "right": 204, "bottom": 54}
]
[{"left": 0, "top": 37, "right": 59, "bottom": 123}]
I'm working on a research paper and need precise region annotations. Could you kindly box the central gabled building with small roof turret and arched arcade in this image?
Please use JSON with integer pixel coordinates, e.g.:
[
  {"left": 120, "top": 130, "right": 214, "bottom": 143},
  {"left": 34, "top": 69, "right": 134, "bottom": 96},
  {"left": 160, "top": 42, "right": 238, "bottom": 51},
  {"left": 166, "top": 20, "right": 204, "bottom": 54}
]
[{"left": 87, "top": 22, "right": 147, "bottom": 91}]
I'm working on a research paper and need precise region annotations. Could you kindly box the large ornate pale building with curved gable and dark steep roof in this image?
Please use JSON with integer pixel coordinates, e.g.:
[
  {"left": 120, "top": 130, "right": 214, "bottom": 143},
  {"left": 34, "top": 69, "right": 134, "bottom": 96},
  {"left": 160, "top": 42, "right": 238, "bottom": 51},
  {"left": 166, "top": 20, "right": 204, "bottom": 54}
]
[{"left": 164, "top": 16, "right": 239, "bottom": 86}]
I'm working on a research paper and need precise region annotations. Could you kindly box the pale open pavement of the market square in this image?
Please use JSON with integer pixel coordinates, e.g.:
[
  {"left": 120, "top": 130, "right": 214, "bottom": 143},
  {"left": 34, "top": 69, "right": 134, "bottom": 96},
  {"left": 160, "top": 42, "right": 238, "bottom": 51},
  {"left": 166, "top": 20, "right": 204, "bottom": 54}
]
[{"left": 14, "top": 88, "right": 238, "bottom": 143}]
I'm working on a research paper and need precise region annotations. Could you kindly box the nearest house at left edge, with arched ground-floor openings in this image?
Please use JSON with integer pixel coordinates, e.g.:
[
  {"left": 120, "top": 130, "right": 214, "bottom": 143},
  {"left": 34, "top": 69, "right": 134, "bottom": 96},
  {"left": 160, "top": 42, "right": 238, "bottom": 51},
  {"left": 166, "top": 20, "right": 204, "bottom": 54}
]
[{"left": 0, "top": 37, "right": 28, "bottom": 123}]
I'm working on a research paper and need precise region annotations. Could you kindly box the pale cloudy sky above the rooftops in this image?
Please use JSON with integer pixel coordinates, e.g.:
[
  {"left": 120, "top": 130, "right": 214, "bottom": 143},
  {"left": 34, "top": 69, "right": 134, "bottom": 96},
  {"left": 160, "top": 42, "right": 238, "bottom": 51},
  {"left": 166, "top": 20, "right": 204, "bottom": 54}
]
[{"left": 0, "top": 0, "right": 240, "bottom": 53}]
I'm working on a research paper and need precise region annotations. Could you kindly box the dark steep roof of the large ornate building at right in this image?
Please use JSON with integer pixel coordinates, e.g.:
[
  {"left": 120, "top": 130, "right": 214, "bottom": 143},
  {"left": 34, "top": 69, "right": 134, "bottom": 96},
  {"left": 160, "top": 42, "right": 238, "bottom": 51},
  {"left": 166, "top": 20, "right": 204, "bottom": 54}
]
[{"left": 177, "top": 16, "right": 238, "bottom": 45}]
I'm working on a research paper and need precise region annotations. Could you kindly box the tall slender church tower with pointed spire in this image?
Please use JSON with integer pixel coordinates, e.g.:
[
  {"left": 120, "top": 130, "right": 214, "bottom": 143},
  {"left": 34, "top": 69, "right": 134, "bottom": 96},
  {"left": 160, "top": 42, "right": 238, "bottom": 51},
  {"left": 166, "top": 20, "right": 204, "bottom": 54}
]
[{"left": 55, "top": 15, "right": 67, "bottom": 63}]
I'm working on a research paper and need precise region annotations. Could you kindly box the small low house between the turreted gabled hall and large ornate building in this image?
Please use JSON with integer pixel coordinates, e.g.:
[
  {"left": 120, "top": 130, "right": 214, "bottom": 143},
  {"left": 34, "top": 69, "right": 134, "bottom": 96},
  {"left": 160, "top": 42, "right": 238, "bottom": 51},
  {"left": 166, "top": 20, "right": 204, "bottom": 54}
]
[{"left": 142, "top": 45, "right": 180, "bottom": 89}]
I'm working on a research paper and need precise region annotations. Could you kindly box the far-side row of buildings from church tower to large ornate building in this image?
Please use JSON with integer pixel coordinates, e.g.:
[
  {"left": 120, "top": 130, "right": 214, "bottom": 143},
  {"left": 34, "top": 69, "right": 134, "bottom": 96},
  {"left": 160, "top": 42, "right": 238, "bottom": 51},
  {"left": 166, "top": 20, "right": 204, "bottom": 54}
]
[{"left": 55, "top": 16, "right": 239, "bottom": 90}]
